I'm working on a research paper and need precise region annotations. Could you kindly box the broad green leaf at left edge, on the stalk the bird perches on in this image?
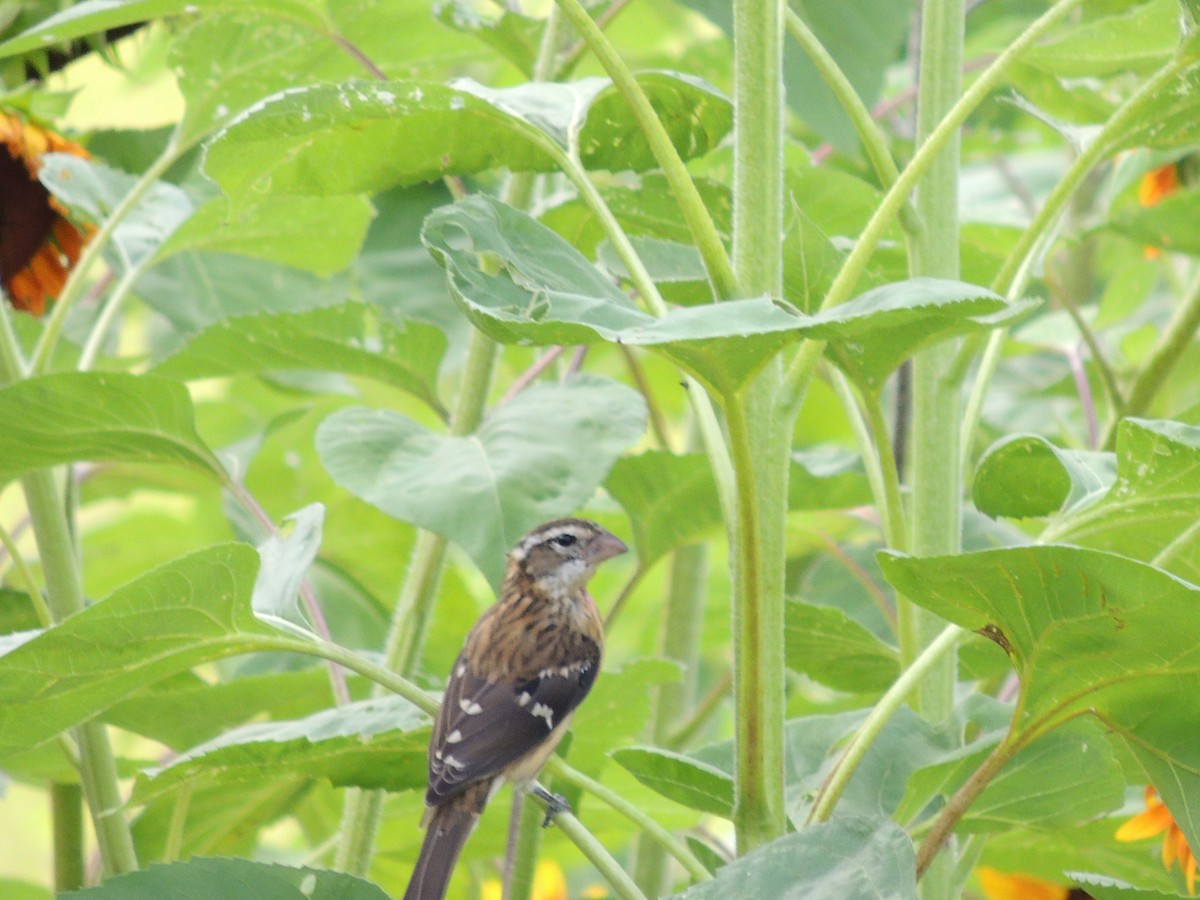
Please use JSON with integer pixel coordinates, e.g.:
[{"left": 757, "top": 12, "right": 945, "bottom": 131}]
[{"left": 0, "top": 544, "right": 277, "bottom": 757}]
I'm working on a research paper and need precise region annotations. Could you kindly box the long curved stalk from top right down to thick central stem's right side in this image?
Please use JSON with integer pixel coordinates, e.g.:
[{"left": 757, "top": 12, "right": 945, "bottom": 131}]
[{"left": 781, "top": 0, "right": 1084, "bottom": 420}]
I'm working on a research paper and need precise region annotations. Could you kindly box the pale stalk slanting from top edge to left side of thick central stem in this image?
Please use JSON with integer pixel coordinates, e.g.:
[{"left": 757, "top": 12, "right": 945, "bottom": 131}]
[{"left": 556, "top": 0, "right": 739, "bottom": 300}]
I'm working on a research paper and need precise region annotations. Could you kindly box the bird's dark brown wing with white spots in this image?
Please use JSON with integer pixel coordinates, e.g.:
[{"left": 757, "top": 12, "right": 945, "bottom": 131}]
[{"left": 425, "top": 642, "right": 600, "bottom": 805}]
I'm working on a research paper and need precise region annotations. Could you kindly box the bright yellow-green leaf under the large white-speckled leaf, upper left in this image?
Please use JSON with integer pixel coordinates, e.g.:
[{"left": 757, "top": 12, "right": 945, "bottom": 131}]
[{"left": 158, "top": 197, "right": 372, "bottom": 275}]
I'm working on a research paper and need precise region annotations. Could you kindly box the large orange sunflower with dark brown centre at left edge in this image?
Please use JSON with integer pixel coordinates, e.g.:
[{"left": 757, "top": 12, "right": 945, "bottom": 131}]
[{"left": 0, "top": 109, "right": 89, "bottom": 316}]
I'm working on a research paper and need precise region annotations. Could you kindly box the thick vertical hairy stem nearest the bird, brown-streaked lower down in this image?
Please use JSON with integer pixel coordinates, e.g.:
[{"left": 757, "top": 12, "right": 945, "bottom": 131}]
[{"left": 724, "top": 0, "right": 794, "bottom": 853}]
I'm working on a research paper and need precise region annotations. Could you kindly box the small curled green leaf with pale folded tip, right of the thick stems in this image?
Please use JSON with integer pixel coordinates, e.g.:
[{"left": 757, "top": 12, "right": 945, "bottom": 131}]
[{"left": 971, "top": 434, "right": 1116, "bottom": 518}]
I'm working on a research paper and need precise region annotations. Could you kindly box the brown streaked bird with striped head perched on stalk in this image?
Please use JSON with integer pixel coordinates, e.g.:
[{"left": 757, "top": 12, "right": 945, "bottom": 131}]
[{"left": 404, "top": 518, "right": 628, "bottom": 900}]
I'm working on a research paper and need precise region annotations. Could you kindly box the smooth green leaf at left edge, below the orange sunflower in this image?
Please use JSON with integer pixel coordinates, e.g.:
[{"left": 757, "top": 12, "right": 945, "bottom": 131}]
[{"left": 0, "top": 372, "right": 224, "bottom": 482}]
